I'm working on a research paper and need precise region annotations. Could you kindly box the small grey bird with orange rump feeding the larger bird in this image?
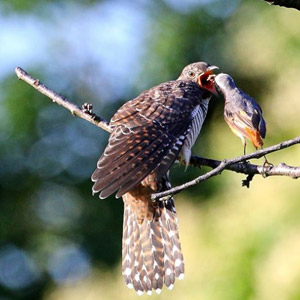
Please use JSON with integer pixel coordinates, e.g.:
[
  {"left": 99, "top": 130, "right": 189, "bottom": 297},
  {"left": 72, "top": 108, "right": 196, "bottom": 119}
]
[{"left": 215, "top": 73, "right": 267, "bottom": 156}]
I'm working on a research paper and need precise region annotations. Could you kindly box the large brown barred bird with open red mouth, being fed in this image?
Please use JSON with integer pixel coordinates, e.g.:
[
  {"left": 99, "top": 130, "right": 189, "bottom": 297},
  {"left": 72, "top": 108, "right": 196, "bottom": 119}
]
[{"left": 92, "top": 62, "right": 216, "bottom": 294}]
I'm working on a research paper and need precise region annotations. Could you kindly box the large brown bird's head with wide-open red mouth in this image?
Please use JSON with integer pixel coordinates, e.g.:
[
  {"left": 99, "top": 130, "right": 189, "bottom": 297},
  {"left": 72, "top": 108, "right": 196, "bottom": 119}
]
[{"left": 178, "top": 62, "right": 218, "bottom": 95}]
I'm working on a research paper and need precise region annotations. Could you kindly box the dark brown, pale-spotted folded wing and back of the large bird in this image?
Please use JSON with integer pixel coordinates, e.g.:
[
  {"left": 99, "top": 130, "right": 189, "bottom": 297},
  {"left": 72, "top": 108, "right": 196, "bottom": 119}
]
[{"left": 92, "top": 81, "right": 201, "bottom": 198}]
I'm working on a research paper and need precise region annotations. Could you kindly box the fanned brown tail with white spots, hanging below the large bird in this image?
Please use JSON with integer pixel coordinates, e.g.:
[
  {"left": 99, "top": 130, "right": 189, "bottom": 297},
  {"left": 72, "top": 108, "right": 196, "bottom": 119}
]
[{"left": 122, "top": 175, "right": 184, "bottom": 295}]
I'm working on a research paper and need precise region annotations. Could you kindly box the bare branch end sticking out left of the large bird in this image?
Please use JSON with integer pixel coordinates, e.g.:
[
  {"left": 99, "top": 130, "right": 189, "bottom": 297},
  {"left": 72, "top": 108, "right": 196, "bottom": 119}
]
[{"left": 15, "top": 67, "right": 111, "bottom": 132}]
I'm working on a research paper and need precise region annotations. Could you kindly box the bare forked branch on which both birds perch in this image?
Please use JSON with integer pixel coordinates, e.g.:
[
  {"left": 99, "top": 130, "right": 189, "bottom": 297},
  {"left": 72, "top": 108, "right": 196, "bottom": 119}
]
[{"left": 15, "top": 67, "right": 300, "bottom": 200}]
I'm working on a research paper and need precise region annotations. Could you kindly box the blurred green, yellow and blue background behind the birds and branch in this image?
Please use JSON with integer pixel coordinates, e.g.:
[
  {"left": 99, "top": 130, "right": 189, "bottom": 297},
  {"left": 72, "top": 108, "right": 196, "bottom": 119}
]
[{"left": 0, "top": 0, "right": 300, "bottom": 300}]
